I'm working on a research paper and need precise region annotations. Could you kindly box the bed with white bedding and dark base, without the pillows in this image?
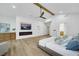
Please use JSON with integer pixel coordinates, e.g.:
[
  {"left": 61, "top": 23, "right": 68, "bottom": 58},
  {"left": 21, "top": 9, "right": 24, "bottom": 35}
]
[{"left": 38, "top": 37, "right": 79, "bottom": 56}]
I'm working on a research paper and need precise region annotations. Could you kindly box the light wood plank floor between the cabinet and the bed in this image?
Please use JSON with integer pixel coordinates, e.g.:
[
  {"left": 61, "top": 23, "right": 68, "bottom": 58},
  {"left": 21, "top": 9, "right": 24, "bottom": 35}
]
[{"left": 5, "top": 35, "right": 49, "bottom": 56}]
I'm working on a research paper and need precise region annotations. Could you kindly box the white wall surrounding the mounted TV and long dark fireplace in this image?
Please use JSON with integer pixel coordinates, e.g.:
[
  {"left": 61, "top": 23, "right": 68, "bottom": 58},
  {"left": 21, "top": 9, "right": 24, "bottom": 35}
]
[{"left": 16, "top": 17, "right": 48, "bottom": 39}]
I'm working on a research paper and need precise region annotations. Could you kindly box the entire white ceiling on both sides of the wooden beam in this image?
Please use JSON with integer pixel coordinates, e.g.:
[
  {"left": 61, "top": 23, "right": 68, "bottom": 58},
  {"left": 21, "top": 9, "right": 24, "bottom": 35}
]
[{"left": 0, "top": 3, "right": 79, "bottom": 18}]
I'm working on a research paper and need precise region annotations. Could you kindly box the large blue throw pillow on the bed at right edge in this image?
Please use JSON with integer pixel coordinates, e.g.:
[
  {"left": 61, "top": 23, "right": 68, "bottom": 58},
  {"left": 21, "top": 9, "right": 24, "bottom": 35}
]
[{"left": 66, "top": 39, "right": 79, "bottom": 51}]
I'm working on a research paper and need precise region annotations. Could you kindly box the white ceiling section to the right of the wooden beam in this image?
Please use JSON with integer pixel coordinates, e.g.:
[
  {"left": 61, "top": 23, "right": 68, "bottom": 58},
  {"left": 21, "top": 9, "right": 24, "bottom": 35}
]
[{"left": 42, "top": 3, "right": 79, "bottom": 15}]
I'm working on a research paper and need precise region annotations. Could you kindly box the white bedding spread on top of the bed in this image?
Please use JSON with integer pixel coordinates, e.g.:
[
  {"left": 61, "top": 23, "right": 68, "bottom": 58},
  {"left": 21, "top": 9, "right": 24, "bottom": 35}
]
[{"left": 39, "top": 37, "right": 79, "bottom": 56}]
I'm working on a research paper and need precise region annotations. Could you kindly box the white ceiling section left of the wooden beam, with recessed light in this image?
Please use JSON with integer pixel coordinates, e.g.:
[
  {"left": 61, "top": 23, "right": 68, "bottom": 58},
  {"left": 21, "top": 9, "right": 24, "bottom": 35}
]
[{"left": 0, "top": 3, "right": 39, "bottom": 17}]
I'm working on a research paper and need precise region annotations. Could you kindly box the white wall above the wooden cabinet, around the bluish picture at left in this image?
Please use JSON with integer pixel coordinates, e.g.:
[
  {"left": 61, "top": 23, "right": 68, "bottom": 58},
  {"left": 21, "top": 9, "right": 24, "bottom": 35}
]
[{"left": 0, "top": 17, "right": 16, "bottom": 32}]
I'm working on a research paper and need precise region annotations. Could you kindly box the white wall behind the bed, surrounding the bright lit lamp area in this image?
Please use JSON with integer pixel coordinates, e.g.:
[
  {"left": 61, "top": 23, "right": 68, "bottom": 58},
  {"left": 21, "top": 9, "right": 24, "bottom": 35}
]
[{"left": 50, "top": 15, "right": 79, "bottom": 36}]
